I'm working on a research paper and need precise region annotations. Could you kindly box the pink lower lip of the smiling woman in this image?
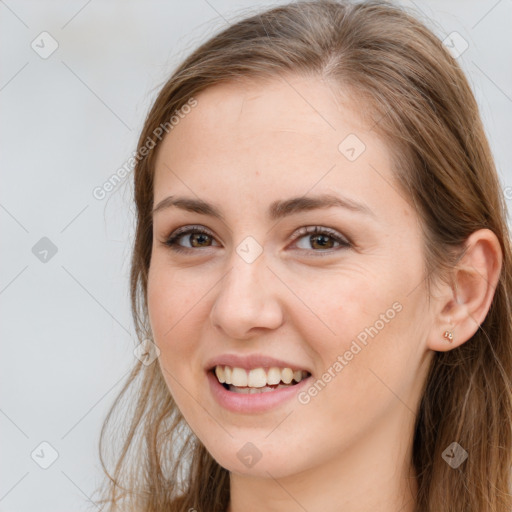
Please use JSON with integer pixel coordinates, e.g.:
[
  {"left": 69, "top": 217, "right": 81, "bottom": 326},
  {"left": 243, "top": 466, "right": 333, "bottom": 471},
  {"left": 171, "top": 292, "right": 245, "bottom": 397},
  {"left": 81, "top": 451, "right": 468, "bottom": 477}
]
[{"left": 207, "top": 371, "right": 311, "bottom": 413}]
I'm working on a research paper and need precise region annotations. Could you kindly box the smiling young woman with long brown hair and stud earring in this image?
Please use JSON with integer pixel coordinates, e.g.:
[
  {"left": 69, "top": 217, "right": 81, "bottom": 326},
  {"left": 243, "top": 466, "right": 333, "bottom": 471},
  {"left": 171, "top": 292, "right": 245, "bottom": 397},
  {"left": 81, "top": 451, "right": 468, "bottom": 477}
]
[{"left": 96, "top": 1, "right": 512, "bottom": 512}]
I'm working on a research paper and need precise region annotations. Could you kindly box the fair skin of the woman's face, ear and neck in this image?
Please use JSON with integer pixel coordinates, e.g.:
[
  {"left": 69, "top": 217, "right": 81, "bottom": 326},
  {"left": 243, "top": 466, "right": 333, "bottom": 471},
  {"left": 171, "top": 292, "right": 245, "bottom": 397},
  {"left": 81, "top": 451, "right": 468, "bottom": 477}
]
[{"left": 148, "top": 76, "right": 501, "bottom": 512}]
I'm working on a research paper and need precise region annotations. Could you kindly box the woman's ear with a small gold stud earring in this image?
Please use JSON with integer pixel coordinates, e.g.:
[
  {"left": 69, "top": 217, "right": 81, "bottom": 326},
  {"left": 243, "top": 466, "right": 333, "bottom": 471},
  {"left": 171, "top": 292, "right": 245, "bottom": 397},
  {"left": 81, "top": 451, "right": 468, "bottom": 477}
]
[{"left": 427, "top": 229, "right": 503, "bottom": 352}]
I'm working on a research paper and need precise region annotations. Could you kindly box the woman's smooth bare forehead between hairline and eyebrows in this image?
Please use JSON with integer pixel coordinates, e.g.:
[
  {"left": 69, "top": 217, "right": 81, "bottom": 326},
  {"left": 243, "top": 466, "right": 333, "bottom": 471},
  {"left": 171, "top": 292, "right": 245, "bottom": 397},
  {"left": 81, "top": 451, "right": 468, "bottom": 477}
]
[{"left": 154, "top": 77, "right": 396, "bottom": 218}]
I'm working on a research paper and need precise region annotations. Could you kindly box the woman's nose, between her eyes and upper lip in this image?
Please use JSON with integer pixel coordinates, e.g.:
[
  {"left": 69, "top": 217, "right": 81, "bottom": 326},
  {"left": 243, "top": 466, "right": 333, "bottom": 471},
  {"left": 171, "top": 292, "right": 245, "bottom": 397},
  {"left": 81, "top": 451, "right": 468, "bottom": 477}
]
[{"left": 210, "top": 249, "right": 283, "bottom": 340}]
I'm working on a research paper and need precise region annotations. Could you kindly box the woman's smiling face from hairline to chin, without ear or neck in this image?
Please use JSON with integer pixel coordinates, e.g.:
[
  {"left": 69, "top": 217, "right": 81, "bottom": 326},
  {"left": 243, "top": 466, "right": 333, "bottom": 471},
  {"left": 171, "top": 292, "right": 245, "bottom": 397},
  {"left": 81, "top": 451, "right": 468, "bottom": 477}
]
[{"left": 148, "top": 77, "right": 433, "bottom": 477}]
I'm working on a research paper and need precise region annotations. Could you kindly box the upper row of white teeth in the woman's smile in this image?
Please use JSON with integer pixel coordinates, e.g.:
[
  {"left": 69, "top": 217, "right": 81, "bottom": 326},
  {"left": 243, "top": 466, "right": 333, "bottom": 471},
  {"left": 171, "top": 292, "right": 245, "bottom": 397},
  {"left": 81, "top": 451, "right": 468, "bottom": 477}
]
[{"left": 215, "top": 366, "right": 308, "bottom": 386}]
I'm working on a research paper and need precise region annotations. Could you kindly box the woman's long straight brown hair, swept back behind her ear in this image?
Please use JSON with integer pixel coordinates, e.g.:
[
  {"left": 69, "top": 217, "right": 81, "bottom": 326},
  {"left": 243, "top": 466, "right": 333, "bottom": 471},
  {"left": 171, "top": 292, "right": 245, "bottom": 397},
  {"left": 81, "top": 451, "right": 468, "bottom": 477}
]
[{"left": 95, "top": 0, "right": 512, "bottom": 512}]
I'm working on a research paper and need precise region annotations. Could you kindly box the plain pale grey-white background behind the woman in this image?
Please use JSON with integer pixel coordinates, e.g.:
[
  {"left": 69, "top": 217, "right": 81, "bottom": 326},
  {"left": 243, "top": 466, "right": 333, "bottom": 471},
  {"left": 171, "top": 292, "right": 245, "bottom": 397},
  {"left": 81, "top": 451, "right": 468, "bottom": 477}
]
[{"left": 0, "top": 0, "right": 512, "bottom": 512}]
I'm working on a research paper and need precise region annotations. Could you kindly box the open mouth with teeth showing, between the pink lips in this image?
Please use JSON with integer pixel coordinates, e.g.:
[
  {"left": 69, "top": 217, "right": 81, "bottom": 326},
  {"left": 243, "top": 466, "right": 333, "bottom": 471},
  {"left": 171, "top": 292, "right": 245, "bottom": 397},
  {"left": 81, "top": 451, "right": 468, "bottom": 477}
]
[{"left": 209, "top": 365, "right": 311, "bottom": 395}]
